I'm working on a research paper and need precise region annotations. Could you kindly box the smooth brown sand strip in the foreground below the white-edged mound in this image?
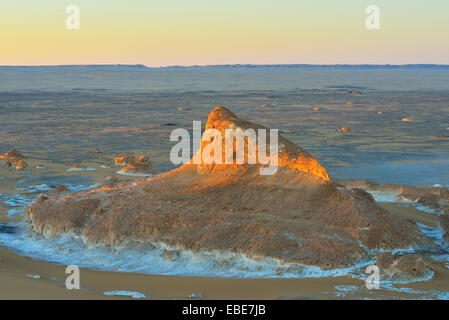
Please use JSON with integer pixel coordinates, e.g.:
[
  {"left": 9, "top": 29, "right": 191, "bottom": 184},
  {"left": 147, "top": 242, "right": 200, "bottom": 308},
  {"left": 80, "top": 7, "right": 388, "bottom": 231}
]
[{"left": 0, "top": 245, "right": 361, "bottom": 299}]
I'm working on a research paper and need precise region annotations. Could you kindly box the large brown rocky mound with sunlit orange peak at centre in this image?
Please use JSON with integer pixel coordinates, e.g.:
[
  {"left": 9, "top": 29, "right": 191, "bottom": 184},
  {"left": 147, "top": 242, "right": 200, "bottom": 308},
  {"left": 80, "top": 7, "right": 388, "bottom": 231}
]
[{"left": 25, "top": 107, "right": 425, "bottom": 268}]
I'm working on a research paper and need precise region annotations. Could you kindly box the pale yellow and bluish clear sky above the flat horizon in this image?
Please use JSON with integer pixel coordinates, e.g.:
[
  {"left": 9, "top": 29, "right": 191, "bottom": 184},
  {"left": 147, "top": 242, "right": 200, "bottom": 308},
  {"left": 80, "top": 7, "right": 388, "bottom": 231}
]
[{"left": 0, "top": 0, "right": 449, "bottom": 67}]
